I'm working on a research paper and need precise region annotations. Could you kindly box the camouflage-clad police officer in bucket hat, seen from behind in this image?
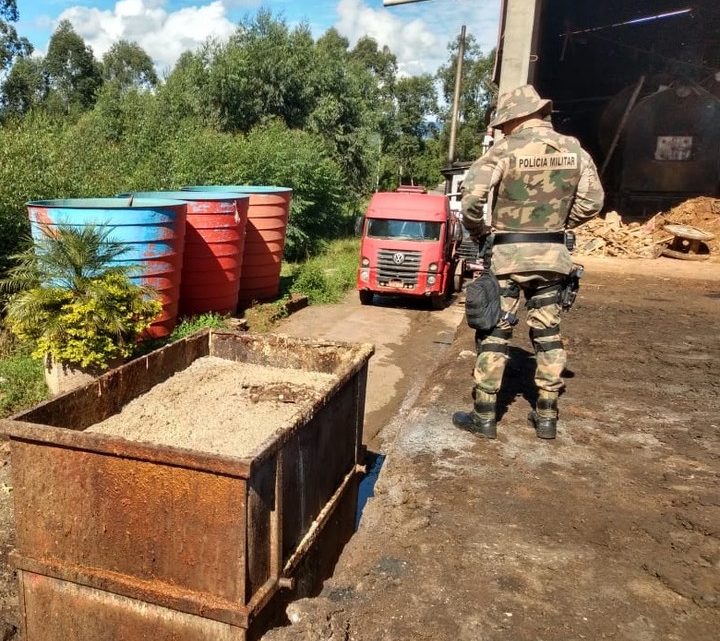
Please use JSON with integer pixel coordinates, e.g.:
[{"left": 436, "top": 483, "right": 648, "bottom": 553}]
[{"left": 453, "top": 85, "right": 604, "bottom": 439}]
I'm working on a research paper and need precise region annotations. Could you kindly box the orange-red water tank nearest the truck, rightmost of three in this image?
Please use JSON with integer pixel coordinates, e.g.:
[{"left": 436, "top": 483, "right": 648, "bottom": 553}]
[{"left": 183, "top": 185, "right": 292, "bottom": 307}]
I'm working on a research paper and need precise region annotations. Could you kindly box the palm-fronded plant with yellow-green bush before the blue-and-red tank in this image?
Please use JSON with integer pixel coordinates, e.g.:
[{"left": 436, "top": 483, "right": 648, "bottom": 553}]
[{"left": 2, "top": 225, "right": 161, "bottom": 369}]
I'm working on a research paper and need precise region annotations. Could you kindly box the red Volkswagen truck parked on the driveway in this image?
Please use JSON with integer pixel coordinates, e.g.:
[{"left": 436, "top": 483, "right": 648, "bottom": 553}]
[{"left": 357, "top": 187, "right": 462, "bottom": 309}]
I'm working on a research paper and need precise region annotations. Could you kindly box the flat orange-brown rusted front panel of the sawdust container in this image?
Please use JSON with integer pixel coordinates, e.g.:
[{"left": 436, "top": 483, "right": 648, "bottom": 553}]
[{"left": 11, "top": 441, "right": 246, "bottom": 604}]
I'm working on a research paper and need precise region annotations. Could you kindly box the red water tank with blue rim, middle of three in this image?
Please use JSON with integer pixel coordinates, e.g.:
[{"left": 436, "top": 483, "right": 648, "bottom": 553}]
[{"left": 124, "top": 191, "right": 250, "bottom": 316}]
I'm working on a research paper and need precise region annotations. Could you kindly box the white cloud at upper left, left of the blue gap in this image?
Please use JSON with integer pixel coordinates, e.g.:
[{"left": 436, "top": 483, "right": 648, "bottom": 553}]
[{"left": 58, "top": 0, "right": 237, "bottom": 70}]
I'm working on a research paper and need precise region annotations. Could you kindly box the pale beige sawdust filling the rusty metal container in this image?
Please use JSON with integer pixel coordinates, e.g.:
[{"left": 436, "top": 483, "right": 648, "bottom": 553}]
[{"left": 88, "top": 356, "right": 337, "bottom": 457}]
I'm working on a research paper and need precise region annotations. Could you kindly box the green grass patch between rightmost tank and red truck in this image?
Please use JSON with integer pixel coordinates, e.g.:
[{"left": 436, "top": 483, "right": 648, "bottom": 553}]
[{"left": 285, "top": 238, "right": 360, "bottom": 305}]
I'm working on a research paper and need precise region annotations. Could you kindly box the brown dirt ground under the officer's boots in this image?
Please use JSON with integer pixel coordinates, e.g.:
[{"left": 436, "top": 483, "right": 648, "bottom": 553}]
[{"left": 264, "top": 259, "right": 720, "bottom": 641}]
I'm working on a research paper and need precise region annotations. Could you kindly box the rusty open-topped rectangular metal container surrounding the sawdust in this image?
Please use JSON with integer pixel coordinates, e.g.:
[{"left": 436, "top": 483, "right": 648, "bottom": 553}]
[{"left": 5, "top": 331, "right": 373, "bottom": 641}]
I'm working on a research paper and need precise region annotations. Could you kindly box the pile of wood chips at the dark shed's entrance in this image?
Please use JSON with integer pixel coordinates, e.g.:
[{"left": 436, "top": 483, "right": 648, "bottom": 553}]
[{"left": 575, "top": 196, "right": 720, "bottom": 258}]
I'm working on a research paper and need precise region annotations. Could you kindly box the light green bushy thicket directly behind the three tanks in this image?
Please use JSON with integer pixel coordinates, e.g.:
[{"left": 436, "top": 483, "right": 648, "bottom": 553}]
[{"left": 0, "top": 108, "right": 355, "bottom": 274}]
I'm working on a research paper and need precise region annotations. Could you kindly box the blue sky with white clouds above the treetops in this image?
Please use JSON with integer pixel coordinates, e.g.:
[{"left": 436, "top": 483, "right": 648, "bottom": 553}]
[{"left": 17, "top": 0, "right": 500, "bottom": 74}]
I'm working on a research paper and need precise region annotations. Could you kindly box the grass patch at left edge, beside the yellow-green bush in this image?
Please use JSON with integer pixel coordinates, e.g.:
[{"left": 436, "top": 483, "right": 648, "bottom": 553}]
[{"left": 0, "top": 339, "right": 48, "bottom": 418}]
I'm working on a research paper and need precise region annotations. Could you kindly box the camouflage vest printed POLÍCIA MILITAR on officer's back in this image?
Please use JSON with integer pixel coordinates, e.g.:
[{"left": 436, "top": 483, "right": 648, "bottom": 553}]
[{"left": 493, "top": 127, "right": 581, "bottom": 232}]
